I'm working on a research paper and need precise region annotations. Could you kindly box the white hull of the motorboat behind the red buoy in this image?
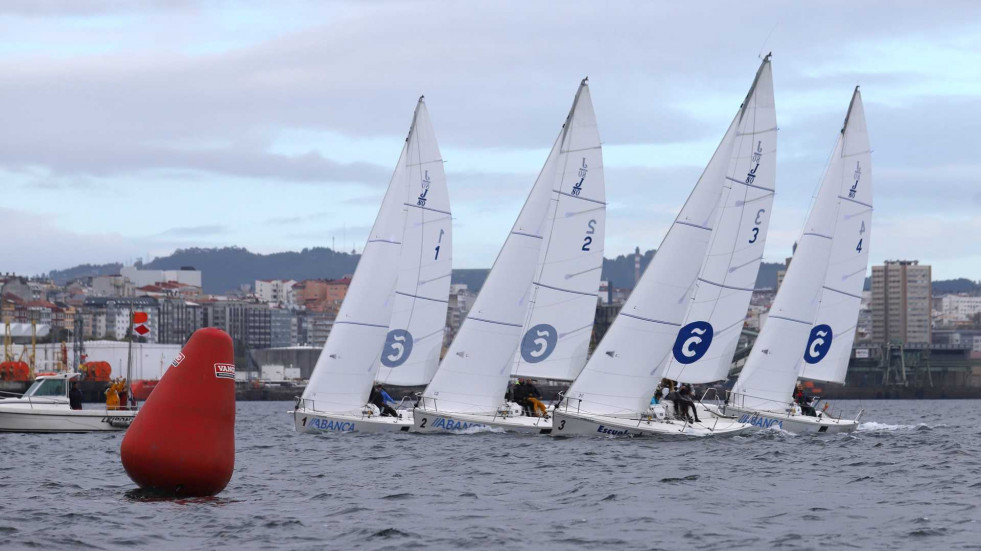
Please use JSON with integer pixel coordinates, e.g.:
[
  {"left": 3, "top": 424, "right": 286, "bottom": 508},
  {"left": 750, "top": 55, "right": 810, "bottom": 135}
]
[{"left": 0, "top": 405, "right": 136, "bottom": 432}]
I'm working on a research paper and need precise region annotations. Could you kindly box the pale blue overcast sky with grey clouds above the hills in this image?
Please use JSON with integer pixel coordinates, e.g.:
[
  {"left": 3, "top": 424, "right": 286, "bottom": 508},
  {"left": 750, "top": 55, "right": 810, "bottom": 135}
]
[{"left": 0, "top": 0, "right": 981, "bottom": 279}]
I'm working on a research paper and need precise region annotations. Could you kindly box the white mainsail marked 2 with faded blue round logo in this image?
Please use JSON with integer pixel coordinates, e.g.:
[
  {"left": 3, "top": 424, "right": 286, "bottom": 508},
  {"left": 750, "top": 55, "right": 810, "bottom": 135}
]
[{"left": 512, "top": 79, "right": 606, "bottom": 381}]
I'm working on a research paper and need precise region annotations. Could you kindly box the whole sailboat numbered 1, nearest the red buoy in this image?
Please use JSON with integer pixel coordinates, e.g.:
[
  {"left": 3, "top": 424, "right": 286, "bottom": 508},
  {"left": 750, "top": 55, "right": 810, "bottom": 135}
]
[{"left": 293, "top": 98, "right": 452, "bottom": 432}]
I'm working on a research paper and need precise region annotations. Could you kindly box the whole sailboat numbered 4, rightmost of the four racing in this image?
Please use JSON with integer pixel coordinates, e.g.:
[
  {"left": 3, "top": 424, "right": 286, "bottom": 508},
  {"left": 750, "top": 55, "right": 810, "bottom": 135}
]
[{"left": 720, "top": 87, "right": 872, "bottom": 432}]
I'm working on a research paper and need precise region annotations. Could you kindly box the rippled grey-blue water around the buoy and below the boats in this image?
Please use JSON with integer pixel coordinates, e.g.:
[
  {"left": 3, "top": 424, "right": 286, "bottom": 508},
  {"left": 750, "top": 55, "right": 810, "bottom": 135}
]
[{"left": 0, "top": 401, "right": 981, "bottom": 550}]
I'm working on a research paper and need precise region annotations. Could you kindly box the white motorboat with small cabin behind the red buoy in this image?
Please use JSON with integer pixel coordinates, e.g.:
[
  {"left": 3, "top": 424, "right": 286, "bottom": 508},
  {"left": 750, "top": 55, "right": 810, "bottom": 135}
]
[{"left": 0, "top": 373, "right": 136, "bottom": 432}]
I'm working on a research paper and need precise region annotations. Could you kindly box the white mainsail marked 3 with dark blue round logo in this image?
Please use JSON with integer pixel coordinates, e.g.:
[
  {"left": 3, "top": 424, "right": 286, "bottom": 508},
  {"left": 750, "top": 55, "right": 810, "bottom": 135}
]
[{"left": 664, "top": 57, "right": 777, "bottom": 383}]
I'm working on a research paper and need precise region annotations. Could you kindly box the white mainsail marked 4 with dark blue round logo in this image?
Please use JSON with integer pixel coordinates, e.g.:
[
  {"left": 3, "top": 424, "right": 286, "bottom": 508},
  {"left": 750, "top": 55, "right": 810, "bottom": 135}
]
[{"left": 801, "top": 87, "right": 872, "bottom": 383}]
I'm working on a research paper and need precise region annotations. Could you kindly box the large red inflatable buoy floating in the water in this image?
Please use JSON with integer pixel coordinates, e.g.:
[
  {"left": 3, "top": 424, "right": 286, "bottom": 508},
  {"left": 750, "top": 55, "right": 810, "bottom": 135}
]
[{"left": 120, "top": 327, "right": 235, "bottom": 496}]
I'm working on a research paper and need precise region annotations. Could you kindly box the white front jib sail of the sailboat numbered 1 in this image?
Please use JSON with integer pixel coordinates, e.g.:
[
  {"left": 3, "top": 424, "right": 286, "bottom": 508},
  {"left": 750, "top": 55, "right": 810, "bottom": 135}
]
[{"left": 303, "top": 98, "right": 424, "bottom": 413}]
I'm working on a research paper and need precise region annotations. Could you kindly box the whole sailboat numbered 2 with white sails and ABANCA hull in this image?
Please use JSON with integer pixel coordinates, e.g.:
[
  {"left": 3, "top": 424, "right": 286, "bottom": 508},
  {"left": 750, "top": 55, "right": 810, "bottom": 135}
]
[{"left": 413, "top": 79, "right": 606, "bottom": 434}]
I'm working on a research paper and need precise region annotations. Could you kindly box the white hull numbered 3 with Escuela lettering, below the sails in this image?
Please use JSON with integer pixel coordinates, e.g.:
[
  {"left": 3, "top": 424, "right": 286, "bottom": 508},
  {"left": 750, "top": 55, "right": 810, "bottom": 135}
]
[{"left": 552, "top": 407, "right": 753, "bottom": 438}]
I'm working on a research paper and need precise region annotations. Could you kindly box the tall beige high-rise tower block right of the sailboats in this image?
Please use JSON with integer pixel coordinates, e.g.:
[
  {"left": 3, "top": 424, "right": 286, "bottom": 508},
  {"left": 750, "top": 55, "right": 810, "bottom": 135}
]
[{"left": 872, "top": 260, "right": 932, "bottom": 344}]
